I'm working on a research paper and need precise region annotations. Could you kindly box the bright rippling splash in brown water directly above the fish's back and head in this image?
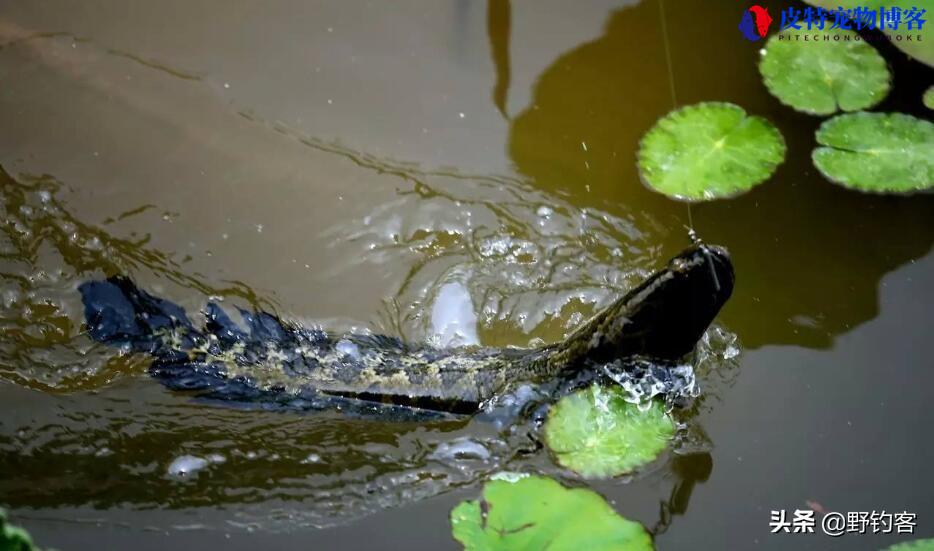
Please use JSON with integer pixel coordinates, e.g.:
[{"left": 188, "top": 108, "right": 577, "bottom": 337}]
[{"left": 327, "top": 166, "right": 659, "bottom": 346}]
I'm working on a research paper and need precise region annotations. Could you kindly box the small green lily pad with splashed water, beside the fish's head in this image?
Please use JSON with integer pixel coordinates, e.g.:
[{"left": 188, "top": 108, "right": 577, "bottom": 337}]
[{"left": 544, "top": 385, "right": 675, "bottom": 478}]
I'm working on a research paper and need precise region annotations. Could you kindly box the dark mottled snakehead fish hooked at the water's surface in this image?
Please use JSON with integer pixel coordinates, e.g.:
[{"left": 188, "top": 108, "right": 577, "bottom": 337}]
[{"left": 79, "top": 245, "right": 734, "bottom": 413}]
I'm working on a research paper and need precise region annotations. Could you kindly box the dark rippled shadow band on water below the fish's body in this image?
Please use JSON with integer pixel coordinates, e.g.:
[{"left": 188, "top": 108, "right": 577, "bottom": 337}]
[{"left": 0, "top": 385, "right": 476, "bottom": 516}]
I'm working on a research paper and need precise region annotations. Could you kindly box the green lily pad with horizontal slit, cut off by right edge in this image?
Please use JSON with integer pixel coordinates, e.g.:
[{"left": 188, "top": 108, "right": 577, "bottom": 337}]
[{"left": 811, "top": 113, "right": 934, "bottom": 193}]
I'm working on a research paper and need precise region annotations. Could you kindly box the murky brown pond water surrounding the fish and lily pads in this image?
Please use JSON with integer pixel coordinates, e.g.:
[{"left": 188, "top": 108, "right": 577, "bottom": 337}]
[{"left": 0, "top": 0, "right": 934, "bottom": 549}]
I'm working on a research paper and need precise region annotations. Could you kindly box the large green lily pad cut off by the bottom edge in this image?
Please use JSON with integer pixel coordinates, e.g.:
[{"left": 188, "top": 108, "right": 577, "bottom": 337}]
[{"left": 451, "top": 476, "right": 653, "bottom": 551}]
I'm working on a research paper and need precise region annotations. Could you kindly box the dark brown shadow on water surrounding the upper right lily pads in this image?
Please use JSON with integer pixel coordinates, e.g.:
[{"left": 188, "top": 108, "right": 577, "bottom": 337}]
[{"left": 509, "top": 1, "right": 934, "bottom": 348}]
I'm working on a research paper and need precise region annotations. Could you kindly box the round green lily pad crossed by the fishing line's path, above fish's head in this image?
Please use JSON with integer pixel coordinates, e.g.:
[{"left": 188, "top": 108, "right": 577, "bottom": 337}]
[{"left": 639, "top": 102, "right": 785, "bottom": 201}]
